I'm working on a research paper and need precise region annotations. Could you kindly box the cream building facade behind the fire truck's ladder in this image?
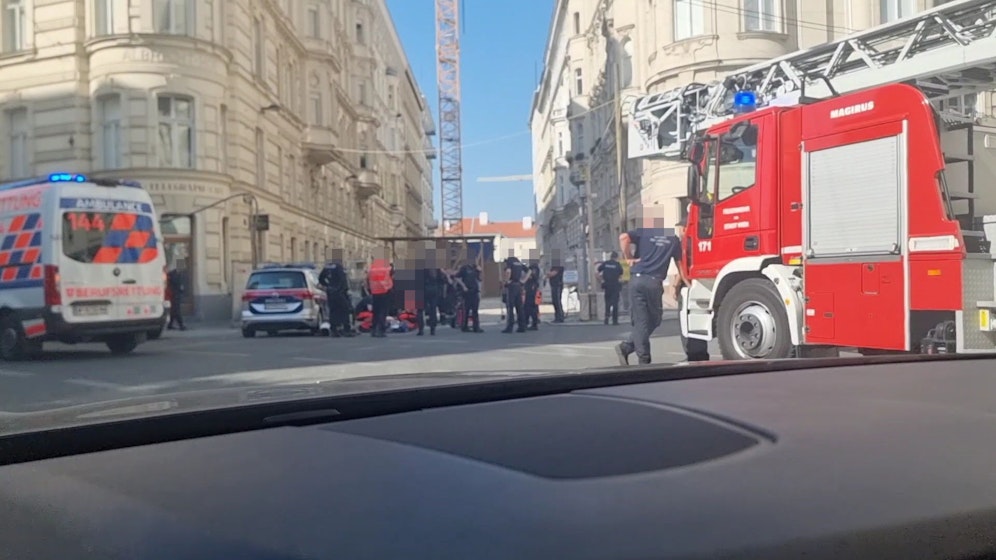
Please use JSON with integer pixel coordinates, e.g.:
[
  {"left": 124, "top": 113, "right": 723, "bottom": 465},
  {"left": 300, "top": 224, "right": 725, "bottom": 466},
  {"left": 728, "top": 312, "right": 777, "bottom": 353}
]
[{"left": 530, "top": 0, "right": 980, "bottom": 284}]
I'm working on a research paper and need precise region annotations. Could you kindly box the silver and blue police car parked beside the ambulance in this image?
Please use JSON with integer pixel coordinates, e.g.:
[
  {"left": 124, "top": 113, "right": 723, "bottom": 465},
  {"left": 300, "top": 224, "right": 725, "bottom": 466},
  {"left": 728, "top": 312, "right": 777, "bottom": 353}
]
[{"left": 242, "top": 263, "right": 328, "bottom": 338}]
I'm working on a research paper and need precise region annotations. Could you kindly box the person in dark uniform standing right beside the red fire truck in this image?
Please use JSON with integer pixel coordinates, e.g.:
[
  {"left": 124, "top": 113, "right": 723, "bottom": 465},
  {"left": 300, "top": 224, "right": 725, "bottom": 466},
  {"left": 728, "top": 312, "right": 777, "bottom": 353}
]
[{"left": 616, "top": 210, "right": 681, "bottom": 365}]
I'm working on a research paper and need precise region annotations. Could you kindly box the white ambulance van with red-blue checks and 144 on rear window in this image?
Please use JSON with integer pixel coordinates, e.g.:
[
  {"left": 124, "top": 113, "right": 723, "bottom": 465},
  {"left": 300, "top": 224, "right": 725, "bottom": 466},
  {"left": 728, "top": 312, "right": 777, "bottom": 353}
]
[{"left": 0, "top": 173, "right": 167, "bottom": 360}]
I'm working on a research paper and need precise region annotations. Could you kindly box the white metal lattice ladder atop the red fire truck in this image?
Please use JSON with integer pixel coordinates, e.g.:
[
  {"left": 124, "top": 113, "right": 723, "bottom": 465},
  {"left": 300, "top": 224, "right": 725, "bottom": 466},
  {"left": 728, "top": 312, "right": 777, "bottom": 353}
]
[{"left": 631, "top": 0, "right": 996, "bottom": 158}]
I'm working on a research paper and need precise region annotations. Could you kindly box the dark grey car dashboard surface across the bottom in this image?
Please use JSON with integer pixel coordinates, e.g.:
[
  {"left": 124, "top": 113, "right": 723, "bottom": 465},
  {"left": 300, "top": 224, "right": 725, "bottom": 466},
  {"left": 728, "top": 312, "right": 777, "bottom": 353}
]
[{"left": 0, "top": 360, "right": 996, "bottom": 560}]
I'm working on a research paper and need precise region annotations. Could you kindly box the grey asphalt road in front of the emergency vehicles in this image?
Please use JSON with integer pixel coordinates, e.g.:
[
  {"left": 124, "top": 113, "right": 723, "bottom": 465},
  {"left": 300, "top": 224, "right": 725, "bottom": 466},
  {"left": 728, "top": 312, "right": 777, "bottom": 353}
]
[{"left": 0, "top": 312, "right": 716, "bottom": 412}]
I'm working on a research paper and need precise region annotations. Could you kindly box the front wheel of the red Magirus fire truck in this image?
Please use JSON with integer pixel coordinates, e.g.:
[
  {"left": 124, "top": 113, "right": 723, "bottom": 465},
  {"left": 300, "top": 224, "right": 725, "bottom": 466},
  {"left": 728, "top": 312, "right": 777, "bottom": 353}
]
[{"left": 717, "top": 278, "right": 792, "bottom": 360}]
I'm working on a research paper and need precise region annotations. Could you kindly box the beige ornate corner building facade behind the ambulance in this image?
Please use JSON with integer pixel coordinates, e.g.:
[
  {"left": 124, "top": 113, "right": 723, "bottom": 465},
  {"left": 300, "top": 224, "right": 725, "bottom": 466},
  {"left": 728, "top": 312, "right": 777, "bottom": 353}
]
[{"left": 0, "top": 0, "right": 433, "bottom": 320}]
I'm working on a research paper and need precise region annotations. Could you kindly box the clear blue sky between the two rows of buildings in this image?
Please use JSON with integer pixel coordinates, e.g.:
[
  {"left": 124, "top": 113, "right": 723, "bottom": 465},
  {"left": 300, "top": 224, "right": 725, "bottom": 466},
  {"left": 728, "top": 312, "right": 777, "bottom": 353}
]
[{"left": 387, "top": 0, "right": 553, "bottom": 221}]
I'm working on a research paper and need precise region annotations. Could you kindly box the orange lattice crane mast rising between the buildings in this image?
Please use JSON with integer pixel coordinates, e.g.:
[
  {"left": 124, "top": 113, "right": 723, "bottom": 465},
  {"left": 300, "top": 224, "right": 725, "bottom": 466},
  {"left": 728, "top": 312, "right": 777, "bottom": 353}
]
[{"left": 436, "top": 0, "right": 463, "bottom": 236}]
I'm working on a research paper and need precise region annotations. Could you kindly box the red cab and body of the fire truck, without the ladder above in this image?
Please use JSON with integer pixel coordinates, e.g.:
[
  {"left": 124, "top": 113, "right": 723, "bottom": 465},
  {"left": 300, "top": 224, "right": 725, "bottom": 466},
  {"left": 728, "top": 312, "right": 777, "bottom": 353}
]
[{"left": 680, "top": 84, "right": 996, "bottom": 359}]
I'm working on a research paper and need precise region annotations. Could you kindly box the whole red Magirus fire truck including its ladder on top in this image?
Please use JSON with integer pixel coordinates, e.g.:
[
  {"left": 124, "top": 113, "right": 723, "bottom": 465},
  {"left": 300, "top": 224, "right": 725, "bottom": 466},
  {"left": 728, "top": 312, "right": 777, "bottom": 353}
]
[{"left": 631, "top": 0, "right": 996, "bottom": 360}]
